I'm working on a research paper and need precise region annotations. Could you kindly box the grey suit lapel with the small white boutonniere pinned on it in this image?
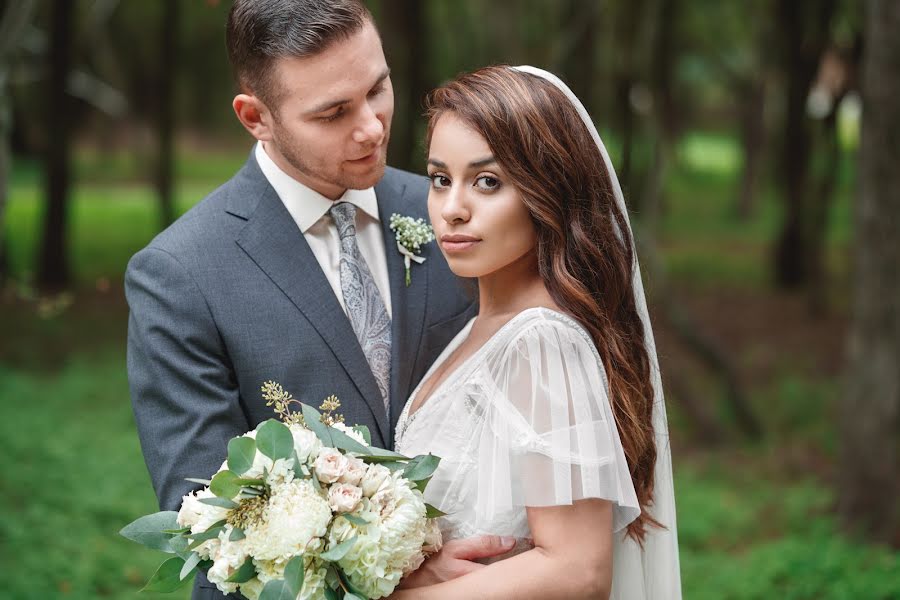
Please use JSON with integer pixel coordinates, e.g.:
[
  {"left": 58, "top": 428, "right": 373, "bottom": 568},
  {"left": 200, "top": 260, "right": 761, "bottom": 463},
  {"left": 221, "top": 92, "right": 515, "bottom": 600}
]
[{"left": 375, "top": 171, "right": 429, "bottom": 445}]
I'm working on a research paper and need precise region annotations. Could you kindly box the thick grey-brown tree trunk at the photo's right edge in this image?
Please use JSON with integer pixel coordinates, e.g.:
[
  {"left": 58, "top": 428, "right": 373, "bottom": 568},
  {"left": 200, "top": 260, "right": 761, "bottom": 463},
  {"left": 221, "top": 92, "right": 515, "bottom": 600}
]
[{"left": 838, "top": 0, "right": 900, "bottom": 547}]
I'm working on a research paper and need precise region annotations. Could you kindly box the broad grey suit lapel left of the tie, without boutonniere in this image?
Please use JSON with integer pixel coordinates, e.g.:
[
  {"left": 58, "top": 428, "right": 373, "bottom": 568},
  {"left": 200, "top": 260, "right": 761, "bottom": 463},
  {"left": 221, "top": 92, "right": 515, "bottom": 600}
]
[{"left": 228, "top": 155, "right": 388, "bottom": 440}]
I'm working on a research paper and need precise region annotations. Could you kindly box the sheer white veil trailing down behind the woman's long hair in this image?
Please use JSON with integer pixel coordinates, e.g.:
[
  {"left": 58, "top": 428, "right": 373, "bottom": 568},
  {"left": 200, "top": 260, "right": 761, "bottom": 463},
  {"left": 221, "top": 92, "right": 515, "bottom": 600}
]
[{"left": 512, "top": 65, "right": 681, "bottom": 600}]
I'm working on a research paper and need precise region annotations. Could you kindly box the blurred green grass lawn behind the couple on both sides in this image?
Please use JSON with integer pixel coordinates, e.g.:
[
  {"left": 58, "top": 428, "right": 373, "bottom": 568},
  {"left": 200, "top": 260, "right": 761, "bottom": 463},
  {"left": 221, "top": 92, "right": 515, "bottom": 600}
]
[{"left": 0, "top": 135, "right": 900, "bottom": 600}]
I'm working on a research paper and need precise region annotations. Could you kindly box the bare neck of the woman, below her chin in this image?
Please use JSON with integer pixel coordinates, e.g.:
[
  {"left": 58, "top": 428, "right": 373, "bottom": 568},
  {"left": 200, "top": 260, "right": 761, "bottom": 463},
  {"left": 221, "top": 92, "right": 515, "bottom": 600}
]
[{"left": 478, "top": 252, "right": 556, "bottom": 318}]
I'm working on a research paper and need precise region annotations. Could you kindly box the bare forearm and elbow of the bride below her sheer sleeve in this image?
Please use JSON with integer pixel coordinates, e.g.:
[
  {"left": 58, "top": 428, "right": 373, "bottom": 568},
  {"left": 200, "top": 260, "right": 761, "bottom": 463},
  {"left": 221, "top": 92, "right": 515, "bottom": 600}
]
[{"left": 390, "top": 499, "right": 612, "bottom": 600}]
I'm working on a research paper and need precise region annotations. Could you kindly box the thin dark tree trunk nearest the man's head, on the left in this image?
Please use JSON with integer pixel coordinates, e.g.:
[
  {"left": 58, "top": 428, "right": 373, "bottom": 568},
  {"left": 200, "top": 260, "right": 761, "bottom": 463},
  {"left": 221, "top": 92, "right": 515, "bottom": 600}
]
[{"left": 156, "top": 0, "right": 180, "bottom": 228}]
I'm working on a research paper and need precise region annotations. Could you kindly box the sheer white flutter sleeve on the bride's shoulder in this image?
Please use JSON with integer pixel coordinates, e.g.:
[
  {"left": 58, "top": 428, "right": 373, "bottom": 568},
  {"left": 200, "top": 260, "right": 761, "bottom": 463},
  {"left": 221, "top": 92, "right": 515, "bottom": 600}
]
[{"left": 476, "top": 313, "right": 640, "bottom": 531}]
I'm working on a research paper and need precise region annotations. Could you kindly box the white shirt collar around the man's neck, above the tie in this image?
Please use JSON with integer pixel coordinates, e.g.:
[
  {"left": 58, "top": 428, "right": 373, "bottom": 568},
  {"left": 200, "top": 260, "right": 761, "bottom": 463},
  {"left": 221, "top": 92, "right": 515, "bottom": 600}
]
[{"left": 255, "top": 142, "right": 380, "bottom": 233}]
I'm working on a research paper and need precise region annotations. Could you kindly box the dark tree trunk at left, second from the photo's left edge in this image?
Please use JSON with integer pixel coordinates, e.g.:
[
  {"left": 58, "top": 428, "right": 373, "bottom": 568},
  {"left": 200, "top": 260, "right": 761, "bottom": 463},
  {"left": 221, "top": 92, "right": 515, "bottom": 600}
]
[{"left": 38, "top": 0, "right": 75, "bottom": 291}]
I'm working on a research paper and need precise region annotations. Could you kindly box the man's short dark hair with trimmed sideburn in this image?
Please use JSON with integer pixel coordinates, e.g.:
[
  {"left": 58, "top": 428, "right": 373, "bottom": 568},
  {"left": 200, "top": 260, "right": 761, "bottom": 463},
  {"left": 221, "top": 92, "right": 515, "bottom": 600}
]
[{"left": 232, "top": 0, "right": 372, "bottom": 109}]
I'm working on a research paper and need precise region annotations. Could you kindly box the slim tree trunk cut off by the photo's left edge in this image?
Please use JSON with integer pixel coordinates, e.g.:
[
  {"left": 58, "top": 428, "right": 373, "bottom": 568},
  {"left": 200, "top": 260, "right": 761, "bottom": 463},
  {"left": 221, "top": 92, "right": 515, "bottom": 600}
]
[{"left": 0, "top": 0, "right": 34, "bottom": 289}]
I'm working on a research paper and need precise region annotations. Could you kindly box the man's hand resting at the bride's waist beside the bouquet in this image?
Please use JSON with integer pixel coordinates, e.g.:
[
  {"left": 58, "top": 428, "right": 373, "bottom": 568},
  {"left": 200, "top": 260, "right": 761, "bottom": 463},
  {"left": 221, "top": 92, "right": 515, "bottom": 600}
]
[{"left": 400, "top": 535, "right": 516, "bottom": 589}]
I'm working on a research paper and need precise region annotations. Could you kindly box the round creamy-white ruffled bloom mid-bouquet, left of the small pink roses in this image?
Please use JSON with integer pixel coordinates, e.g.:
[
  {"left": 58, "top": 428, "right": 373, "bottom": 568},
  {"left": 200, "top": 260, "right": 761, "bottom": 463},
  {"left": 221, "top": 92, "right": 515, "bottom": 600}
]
[{"left": 244, "top": 479, "right": 331, "bottom": 561}]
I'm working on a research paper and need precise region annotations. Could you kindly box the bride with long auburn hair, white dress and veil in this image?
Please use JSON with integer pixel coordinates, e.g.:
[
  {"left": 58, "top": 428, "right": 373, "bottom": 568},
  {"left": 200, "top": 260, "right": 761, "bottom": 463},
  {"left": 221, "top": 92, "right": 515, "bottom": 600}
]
[{"left": 392, "top": 67, "right": 681, "bottom": 600}]
